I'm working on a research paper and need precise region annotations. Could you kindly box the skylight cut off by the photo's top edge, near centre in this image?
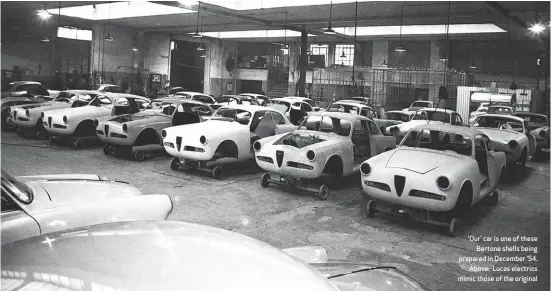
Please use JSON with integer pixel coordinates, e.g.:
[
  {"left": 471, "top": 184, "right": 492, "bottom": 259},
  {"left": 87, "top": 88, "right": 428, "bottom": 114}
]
[{"left": 178, "top": 0, "right": 369, "bottom": 10}]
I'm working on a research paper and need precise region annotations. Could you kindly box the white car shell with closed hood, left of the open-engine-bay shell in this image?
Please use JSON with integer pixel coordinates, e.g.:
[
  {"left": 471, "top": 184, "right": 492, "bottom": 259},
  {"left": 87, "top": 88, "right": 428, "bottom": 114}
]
[{"left": 163, "top": 104, "right": 296, "bottom": 161}]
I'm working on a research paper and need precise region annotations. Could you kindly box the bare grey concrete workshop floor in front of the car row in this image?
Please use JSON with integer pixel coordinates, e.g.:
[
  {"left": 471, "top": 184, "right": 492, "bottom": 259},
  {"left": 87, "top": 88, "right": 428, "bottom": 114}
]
[{"left": 1, "top": 133, "right": 550, "bottom": 290}]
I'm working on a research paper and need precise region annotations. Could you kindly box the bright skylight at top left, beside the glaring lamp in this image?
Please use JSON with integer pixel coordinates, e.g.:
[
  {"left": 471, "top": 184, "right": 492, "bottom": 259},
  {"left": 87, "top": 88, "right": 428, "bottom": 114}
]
[{"left": 47, "top": 1, "right": 195, "bottom": 20}]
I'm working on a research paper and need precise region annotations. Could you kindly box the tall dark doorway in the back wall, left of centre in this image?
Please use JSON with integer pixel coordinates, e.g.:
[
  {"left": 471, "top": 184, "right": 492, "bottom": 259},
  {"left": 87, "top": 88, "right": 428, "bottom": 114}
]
[{"left": 170, "top": 40, "right": 205, "bottom": 93}]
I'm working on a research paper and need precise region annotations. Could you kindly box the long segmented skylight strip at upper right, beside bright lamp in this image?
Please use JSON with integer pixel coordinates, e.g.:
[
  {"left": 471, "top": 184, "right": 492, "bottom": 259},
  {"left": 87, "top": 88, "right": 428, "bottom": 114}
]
[{"left": 333, "top": 23, "right": 506, "bottom": 36}]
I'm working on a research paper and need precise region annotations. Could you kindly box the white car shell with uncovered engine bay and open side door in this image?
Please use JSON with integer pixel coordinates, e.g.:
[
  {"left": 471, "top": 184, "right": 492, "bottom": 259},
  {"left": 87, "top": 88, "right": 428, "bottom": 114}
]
[{"left": 254, "top": 112, "right": 396, "bottom": 179}]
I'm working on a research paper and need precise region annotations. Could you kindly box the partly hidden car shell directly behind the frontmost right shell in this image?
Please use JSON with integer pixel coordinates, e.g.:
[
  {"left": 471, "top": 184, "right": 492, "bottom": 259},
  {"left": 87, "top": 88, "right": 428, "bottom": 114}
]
[{"left": 385, "top": 108, "right": 467, "bottom": 144}]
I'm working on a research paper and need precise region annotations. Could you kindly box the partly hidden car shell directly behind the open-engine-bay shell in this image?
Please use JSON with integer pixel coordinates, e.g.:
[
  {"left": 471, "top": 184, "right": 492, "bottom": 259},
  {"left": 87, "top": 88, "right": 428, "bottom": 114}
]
[{"left": 325, "top": 100, "right": 399, "bottom": 133}]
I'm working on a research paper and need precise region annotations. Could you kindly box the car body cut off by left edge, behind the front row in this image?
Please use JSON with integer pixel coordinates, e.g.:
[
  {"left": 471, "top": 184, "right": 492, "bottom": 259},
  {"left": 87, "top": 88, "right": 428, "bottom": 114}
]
[{"left": 0, "top": 81, "right": 50, "bottom": 131}]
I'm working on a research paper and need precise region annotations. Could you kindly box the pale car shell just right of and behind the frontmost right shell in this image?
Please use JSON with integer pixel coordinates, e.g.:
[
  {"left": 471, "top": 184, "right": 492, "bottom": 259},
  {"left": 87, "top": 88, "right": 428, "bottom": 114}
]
[{"left": 472, "top": 114, "right": 536, "bottom": 165}]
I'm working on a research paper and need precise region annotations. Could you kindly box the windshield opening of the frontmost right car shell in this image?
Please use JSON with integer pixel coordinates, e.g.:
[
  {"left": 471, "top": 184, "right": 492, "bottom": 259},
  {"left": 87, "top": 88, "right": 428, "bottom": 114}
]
[{"left": 400, "top": 129, "right": 472, "bottom": 156}]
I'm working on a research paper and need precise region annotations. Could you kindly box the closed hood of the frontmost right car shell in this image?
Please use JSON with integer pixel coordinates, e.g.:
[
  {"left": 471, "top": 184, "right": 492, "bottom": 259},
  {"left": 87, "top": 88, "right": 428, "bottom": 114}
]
[{"left": 386, "top": 147, "right": 461, "bottom": 174}]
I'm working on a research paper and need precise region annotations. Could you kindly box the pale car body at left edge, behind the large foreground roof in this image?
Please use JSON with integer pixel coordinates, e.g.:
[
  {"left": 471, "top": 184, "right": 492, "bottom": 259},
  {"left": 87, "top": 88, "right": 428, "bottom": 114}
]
[{"left": 1, "top": 171, "right": 172, "bottom": 244}]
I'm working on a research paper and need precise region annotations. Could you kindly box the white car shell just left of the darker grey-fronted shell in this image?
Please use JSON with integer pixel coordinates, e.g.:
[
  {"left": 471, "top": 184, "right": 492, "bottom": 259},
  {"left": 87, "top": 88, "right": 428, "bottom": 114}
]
[{"left": 42, "top": 93, "right": 150, "bottom": 136}]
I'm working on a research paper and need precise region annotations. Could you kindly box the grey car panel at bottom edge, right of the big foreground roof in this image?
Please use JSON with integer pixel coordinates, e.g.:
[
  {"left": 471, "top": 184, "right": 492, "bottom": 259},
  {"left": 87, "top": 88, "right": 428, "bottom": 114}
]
[{"left": 311, "top": 261, "right": 429, "bottom": 291}]
